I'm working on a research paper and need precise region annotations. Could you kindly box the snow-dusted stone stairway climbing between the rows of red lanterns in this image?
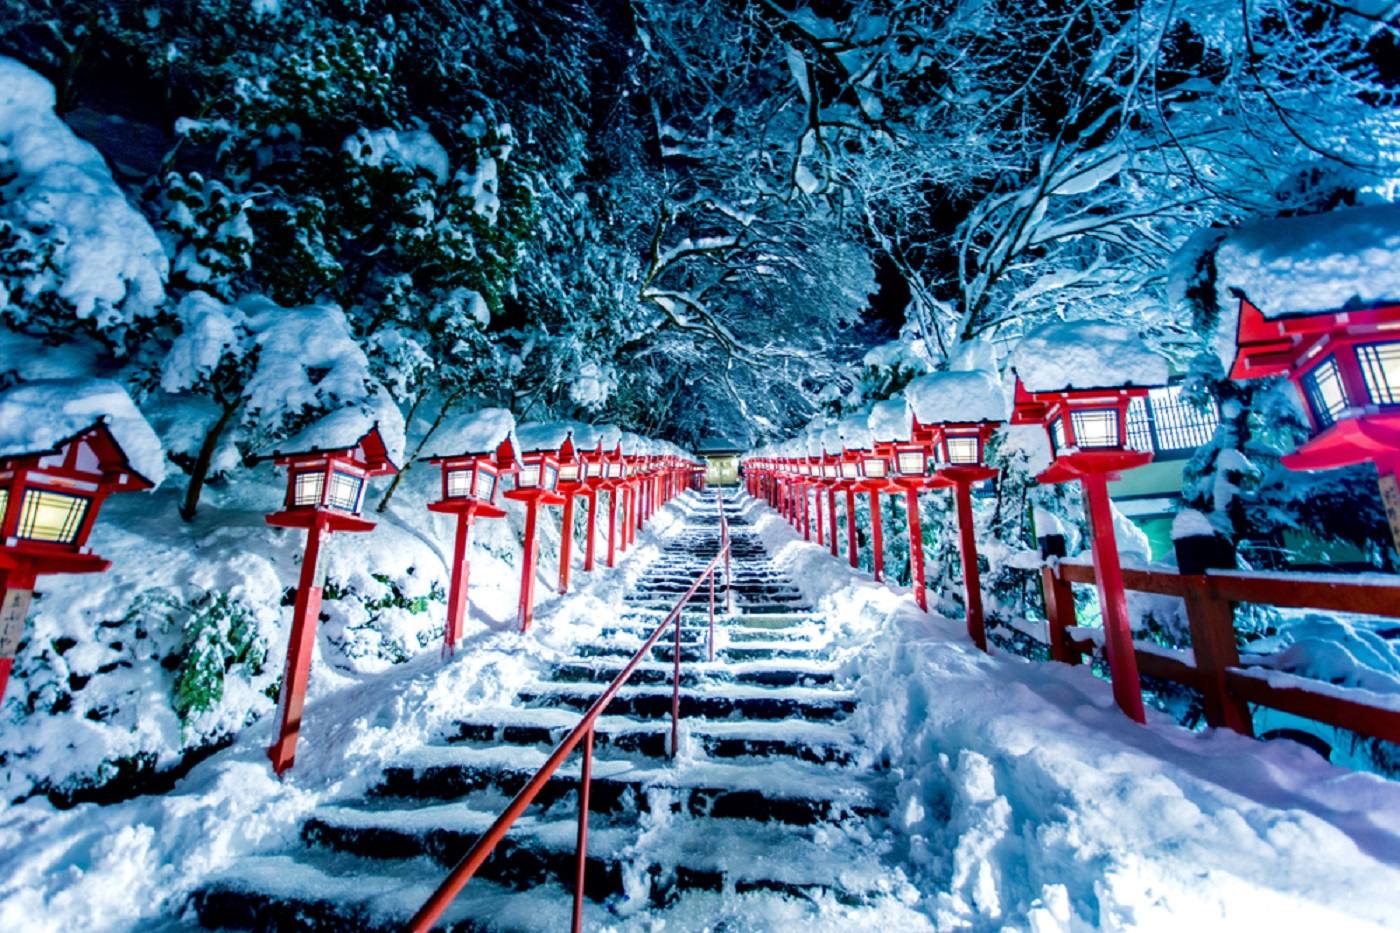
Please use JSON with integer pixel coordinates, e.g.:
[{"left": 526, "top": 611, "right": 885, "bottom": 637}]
[{"left": 190, "top": 492, "right": 924, "bottom": 930}]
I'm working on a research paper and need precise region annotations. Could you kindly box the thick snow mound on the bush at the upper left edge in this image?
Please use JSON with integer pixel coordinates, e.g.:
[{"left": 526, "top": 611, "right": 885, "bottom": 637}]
[{"left": 0, "top": 56, "right": 169, "bottom": 328}]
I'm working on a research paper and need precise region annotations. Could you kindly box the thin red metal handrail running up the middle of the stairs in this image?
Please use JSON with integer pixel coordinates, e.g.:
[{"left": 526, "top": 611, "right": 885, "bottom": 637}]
[{"left": 409, "top": 495, "right": 734, "bottom": 933}]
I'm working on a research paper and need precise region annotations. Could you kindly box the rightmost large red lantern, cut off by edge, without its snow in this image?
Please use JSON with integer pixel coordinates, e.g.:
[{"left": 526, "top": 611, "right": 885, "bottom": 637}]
[{"left": 1229, "top": 300, "right": 1400, "bottom": 551}]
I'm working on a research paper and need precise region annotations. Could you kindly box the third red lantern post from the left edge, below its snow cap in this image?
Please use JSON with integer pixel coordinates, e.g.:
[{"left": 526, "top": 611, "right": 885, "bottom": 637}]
[{"left": 428, "top": 437, "right": 517, "bottom": 654}]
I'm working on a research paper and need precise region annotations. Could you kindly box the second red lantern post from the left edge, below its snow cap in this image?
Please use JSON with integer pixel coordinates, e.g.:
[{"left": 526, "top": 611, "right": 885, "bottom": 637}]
[{"left": 266, "top": 426, "right": 398, "bottom": 776}]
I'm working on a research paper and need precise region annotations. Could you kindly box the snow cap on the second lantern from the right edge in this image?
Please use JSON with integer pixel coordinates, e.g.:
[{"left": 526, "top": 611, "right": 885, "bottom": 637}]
[{"left": 1008, "top": 321, "right": 1170, "bottom": 395}]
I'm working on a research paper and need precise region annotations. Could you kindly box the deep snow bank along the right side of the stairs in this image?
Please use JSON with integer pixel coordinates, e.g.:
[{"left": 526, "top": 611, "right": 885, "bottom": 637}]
[{"left": 757, "top": 510, "right": 1400, "bottom": 930}]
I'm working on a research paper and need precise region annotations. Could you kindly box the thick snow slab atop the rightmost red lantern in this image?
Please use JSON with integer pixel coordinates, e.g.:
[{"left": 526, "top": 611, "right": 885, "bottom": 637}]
[{"left": 1215, "top": 205, "right": 1400, "bottom": 367}]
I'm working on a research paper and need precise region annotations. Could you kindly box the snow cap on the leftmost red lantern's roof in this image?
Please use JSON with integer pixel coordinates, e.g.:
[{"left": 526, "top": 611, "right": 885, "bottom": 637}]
[{"left": 0, "top": 380, "right": 165, "bottom": 486}]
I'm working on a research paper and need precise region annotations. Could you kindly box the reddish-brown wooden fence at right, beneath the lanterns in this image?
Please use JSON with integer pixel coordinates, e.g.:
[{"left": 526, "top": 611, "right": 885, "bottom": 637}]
[{"left": 1042, "top": 560, "right": 1400, "bottom": 742}]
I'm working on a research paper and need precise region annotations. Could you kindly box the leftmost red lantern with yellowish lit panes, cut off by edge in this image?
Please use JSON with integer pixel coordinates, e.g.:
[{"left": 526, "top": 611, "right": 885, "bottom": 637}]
[{"left": 0, "top": 411, "right": 153, "bottom": 699}]
